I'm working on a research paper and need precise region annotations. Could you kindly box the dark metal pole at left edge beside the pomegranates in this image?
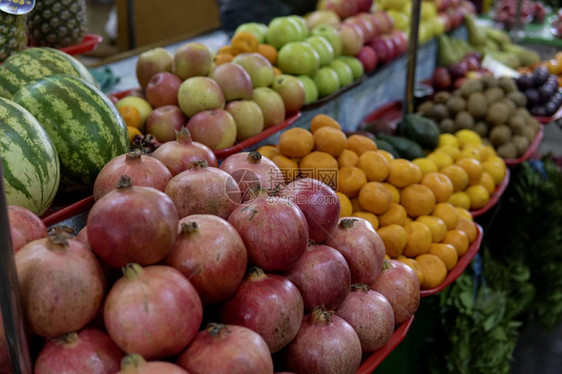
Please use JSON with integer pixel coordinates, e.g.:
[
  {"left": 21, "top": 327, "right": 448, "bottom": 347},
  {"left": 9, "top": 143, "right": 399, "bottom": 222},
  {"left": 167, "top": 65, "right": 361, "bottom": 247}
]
[{"left": 0, "top": 157, "right": 32, "bottom": 374}]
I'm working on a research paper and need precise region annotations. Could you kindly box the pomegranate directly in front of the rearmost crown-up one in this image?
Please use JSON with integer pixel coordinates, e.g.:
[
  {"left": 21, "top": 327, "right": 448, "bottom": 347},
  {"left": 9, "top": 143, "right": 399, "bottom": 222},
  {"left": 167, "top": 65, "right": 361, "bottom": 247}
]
[{"left": 166, "top": 160, "right": 242, "bottom": 219}]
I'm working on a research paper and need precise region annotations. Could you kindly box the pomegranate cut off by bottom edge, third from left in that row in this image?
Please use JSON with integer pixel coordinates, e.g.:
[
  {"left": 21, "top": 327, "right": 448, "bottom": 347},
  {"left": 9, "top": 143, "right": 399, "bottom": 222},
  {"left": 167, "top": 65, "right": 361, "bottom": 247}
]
[{"left": 178, "top": 323, "right": 273, "bottom": 374}]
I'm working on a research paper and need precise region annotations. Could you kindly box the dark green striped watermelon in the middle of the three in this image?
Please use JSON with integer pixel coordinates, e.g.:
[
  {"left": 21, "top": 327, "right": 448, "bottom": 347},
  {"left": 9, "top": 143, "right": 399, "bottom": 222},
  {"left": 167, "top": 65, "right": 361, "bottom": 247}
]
[{"left": 13, "top": 74, "right": 129, "bottom": 189}]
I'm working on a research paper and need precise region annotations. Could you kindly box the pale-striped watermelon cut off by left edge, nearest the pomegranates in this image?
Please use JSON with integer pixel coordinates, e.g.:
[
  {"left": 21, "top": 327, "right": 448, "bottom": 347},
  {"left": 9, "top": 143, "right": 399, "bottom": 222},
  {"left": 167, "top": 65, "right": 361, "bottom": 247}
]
[{"left": 0, "top": 97, "right": 60, "bottom": 215}]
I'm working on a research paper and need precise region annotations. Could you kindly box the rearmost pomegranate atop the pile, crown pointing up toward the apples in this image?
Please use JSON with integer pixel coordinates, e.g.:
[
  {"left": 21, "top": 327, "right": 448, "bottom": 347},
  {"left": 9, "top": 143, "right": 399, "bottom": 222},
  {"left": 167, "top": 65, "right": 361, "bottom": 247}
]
[{"left": 150, "top": 127, "right": 218, "bottom": 177}]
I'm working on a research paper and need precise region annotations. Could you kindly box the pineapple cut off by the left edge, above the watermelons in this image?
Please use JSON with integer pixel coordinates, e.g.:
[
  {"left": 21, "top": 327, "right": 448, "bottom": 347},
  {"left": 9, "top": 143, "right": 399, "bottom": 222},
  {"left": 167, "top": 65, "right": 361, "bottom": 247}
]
[{"left": 0, "top": 11, "right": 27, "bottom": 62}]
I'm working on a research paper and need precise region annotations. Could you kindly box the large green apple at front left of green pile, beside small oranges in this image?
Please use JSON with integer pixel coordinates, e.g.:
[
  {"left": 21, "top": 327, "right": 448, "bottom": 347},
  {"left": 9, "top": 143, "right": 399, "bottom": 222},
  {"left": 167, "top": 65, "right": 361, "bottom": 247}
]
[{"left": 277, "top": 42, "right": 320, "bottom": 77}]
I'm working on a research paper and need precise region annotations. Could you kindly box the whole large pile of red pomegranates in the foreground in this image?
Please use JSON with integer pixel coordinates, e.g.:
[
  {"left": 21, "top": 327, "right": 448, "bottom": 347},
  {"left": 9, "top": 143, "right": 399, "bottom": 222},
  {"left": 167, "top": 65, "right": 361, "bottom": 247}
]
[{"left": 0, "top": 140, "right": 419, "bottom": 374}]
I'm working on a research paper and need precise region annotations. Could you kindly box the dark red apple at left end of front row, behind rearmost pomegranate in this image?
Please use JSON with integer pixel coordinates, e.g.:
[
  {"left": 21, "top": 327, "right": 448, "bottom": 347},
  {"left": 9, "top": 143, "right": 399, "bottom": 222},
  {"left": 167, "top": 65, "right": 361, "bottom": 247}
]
[{"left": 145, "top": 105, "right": 187, "bottom": 143}]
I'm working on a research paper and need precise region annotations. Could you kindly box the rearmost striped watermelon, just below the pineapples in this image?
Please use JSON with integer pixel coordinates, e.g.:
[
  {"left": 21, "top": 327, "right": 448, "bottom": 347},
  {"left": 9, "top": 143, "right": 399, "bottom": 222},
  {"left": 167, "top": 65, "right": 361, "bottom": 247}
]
[{"left": 0, "top": 47, "right": 98, "bottom": 99}]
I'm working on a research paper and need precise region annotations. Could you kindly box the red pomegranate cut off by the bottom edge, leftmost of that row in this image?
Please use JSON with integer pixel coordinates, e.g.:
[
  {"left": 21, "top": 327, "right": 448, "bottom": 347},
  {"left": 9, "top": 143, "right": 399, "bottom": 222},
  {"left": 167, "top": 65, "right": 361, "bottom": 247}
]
[{"left": 34, "top": 328, "right": 123, "bottom": 374}]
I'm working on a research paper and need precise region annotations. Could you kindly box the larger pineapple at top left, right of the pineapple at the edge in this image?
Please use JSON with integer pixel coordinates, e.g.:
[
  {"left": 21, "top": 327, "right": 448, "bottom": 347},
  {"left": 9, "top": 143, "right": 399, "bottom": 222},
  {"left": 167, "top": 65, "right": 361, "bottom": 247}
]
[{"left": 27, "top": 0, "right": 87, "bottom": 48}]
